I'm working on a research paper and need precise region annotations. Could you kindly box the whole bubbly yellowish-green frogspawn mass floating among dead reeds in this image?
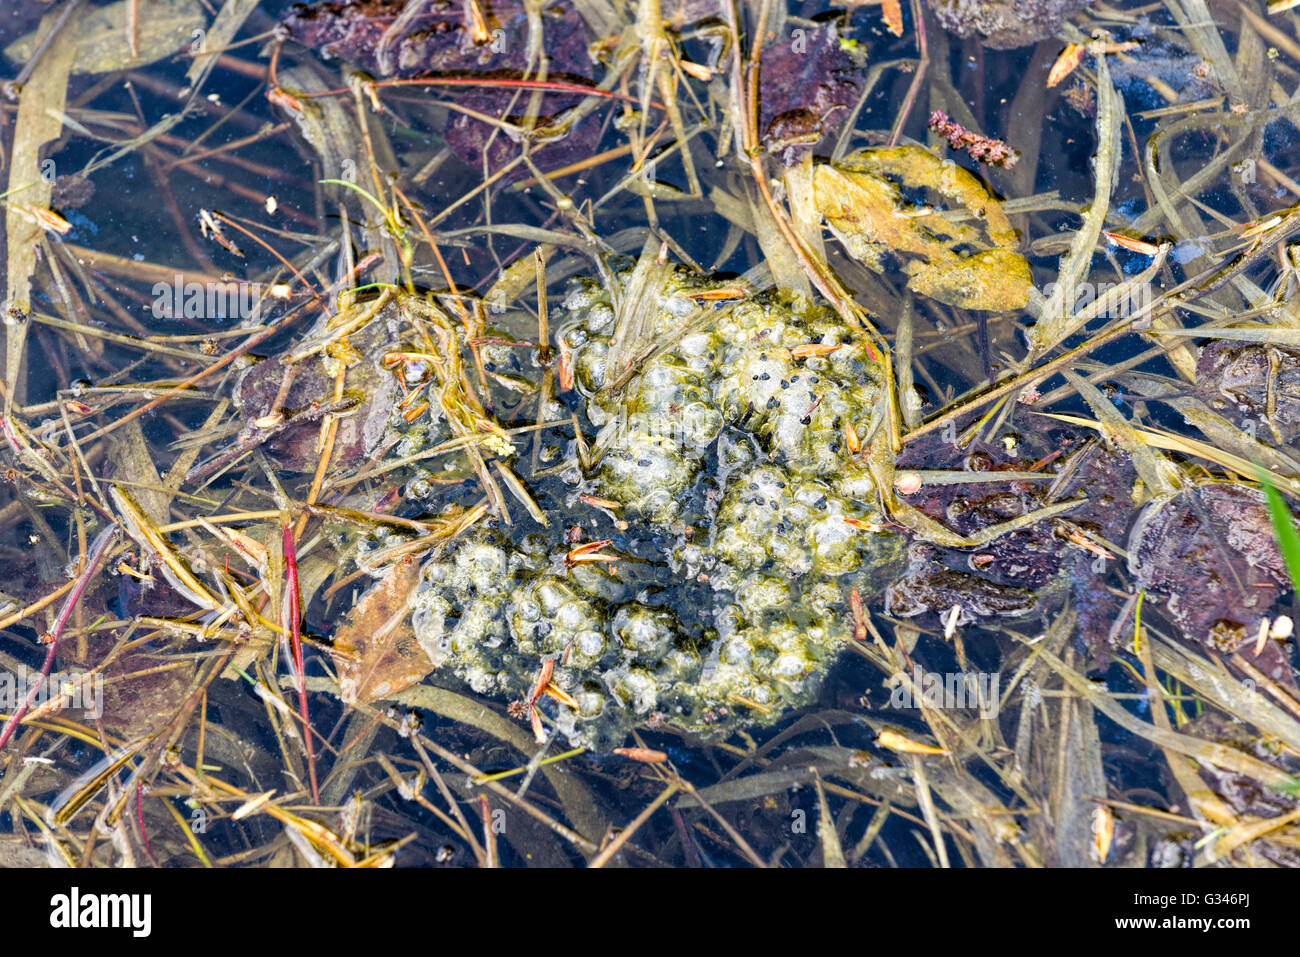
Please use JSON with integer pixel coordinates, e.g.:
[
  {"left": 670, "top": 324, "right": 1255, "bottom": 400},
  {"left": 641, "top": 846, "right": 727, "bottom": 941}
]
[{"left": 412, "top": 273, "right": 901, "bottom": 749}]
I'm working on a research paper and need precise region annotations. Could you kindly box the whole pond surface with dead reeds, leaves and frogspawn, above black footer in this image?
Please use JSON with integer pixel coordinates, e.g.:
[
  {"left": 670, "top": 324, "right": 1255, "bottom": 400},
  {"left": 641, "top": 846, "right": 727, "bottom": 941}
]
[{"left": 0, "top": 0, "right": 1300, "bottom": 867}]
